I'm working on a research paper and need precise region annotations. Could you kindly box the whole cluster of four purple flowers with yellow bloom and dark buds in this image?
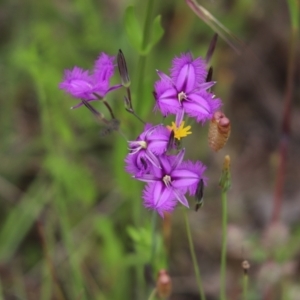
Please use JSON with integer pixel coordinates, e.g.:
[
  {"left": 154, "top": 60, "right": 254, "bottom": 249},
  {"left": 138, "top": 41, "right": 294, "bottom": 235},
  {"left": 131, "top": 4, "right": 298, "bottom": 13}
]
[{"left": 59, "top": 50, "right": 221, "bottom": 217}]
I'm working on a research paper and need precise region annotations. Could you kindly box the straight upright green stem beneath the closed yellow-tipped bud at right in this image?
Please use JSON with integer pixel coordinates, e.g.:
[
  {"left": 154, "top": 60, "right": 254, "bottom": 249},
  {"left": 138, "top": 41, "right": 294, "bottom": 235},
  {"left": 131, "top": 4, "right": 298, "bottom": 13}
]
[{"left": 220, "top": 190, "right": 227, "bottom": 300}]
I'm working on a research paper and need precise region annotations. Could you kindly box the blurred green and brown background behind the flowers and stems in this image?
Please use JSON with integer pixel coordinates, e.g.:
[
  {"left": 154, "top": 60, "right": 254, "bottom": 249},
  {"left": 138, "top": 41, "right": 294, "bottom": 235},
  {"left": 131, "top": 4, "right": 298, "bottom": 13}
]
[{"left": 0, "top": 0, "right": 300, "bottom": 300}]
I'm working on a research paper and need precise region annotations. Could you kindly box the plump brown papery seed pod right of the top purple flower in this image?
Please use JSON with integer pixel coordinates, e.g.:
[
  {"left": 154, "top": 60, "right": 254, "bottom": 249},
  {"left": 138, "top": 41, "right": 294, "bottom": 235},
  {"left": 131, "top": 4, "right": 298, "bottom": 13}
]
[{"left": 208, "top": 111, "right": 231, "bottom": 151}]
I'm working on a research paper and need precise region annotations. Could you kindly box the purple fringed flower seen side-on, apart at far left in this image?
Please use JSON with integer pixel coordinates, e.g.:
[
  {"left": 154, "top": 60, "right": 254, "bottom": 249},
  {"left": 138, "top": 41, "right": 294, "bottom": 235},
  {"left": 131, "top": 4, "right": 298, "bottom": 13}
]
[{"left": 59, "top": 53, "right": 121, "bottom": 108}]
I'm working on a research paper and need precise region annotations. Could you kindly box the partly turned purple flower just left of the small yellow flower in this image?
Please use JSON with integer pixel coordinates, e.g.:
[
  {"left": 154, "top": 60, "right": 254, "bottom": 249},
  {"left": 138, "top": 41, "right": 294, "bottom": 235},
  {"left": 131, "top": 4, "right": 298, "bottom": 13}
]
[{"left": 125, "top": 124, "right": 171, "bottom": 175}]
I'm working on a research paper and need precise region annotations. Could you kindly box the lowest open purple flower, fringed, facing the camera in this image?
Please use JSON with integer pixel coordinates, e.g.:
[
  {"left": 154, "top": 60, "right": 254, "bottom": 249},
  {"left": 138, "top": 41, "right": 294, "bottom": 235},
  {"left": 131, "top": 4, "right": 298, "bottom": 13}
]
[{"left": 135, "top": 149, "right": 205, "bottom": 216}]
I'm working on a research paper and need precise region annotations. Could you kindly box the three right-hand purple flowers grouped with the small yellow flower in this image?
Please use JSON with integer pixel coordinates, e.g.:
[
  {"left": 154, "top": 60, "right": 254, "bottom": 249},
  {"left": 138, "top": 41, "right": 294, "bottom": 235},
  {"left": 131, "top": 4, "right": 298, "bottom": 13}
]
[{"left": 125, "top": 53, "right": 221, "bottom": 216}]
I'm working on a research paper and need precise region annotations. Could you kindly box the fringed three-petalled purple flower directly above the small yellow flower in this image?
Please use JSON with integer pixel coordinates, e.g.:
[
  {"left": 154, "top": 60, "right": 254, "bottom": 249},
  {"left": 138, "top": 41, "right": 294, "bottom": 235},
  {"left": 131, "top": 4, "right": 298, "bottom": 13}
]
[{"left": 155, "top": 53, "right": 221, "bottom": 125}]
